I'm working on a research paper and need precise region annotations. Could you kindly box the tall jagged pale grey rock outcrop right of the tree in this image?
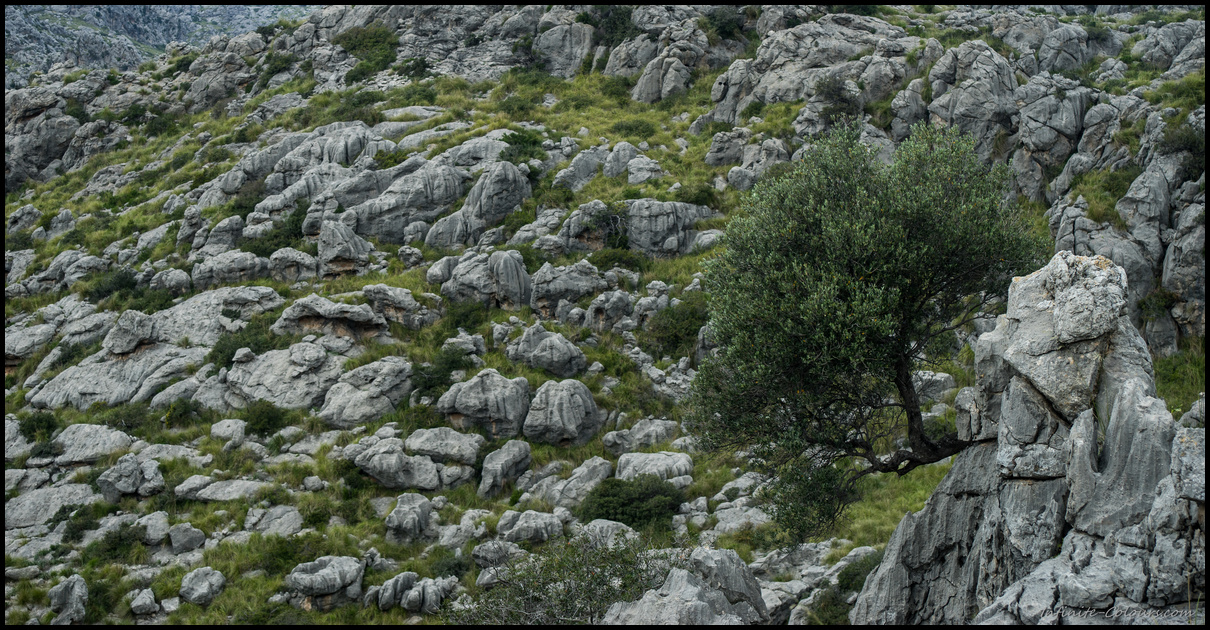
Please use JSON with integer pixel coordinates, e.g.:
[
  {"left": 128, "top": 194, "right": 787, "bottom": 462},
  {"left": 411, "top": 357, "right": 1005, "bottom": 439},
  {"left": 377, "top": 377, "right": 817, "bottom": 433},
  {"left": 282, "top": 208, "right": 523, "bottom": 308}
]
[{"left": 851, "top": 252, "right": 1205, "bottom": 623}]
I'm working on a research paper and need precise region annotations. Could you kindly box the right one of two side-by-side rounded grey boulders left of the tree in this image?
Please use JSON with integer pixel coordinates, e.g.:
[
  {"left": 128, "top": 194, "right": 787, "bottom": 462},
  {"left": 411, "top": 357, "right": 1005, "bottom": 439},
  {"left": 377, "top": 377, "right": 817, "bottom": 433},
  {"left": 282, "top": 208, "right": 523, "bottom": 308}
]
[{"left": 524, "top": 378, "right": 607, "bottom": 446}]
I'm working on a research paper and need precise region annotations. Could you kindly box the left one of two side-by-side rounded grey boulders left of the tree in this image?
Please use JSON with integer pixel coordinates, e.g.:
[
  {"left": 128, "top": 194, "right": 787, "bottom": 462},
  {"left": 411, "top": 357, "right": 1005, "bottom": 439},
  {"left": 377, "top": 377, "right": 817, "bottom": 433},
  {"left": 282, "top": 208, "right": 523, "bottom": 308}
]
[{"left": 437, "top": 368, "right": 530, "bottom": 439}]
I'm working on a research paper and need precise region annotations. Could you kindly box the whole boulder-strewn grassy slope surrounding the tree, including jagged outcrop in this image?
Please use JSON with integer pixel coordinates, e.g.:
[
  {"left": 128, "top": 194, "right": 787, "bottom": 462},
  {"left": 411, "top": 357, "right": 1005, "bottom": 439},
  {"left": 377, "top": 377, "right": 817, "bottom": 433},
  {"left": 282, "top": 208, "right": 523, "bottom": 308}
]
[{"left": 5, "top": 5, "right": 1205, "bottom": 624}]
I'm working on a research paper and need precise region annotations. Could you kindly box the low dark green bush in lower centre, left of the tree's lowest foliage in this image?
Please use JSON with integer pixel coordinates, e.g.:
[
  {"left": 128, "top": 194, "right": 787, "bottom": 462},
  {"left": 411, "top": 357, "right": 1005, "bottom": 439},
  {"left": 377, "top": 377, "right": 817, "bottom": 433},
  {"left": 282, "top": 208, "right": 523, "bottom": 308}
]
[{"left": 580, "top": 475, "right": 685, "bottom": 528}]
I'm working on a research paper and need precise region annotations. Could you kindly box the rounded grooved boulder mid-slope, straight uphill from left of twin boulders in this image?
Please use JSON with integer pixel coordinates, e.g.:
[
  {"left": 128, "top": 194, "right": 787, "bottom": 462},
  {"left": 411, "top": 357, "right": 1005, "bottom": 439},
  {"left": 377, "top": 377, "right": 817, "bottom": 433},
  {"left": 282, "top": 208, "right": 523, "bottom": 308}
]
[{"left": 442, "top": 249, "right": 530, "bottom": 311}]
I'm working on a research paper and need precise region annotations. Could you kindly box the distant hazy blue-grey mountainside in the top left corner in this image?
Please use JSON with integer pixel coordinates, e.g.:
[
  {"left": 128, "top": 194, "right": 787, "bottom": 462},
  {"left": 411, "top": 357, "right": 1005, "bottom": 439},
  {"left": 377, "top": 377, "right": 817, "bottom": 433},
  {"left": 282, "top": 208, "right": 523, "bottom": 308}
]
[{"left": 4, "top": 5, "right": 318, "bottom": 88}]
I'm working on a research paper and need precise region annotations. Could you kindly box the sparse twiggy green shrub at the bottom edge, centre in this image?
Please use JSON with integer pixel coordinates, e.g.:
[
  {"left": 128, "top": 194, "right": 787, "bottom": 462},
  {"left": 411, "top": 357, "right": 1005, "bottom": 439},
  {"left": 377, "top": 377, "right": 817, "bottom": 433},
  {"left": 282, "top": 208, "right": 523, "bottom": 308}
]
[{"left": 443, "top": 529, "right": 686, "bottom": 626}]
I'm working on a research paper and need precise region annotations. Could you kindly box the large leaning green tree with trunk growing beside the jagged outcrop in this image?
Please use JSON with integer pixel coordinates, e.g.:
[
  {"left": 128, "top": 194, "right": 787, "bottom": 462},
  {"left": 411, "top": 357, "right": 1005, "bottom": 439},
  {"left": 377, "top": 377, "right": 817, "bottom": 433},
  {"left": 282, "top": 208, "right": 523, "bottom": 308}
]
[{"left": 690, "top": 122, "right": 1044, "bottom": 538}]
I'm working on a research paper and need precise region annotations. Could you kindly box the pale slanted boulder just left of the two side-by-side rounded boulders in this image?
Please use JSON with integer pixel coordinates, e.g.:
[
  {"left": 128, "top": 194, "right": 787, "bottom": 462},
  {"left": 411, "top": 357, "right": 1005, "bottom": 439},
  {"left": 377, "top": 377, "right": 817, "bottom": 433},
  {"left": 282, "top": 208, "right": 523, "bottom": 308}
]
[{"left": 319, "top": 357, "right": 411, "bottom": 428}]
